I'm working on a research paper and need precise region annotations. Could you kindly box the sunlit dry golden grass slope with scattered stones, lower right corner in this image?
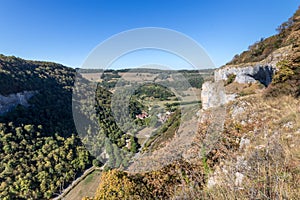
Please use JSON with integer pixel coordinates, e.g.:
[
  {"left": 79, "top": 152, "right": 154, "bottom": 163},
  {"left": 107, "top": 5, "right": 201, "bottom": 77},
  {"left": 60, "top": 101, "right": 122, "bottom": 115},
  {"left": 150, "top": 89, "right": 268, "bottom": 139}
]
[{"left": 182, "top": 95, "right": 300, "bottom": 199}]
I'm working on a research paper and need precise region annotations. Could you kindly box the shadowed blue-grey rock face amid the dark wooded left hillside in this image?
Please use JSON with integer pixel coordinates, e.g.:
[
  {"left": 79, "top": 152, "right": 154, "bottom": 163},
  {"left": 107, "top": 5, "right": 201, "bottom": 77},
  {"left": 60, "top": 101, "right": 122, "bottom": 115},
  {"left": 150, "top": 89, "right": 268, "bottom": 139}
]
[{"left": 0, "top": 91, "right": 36, "bottom": 115}]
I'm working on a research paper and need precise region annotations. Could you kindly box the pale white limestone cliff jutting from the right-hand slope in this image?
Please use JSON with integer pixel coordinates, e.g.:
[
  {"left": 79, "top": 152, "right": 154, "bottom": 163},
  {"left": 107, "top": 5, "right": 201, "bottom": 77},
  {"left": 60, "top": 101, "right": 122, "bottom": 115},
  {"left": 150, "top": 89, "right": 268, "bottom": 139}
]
[{"left": 201, "top": 46, "right": 292, "bottom": 109}]
